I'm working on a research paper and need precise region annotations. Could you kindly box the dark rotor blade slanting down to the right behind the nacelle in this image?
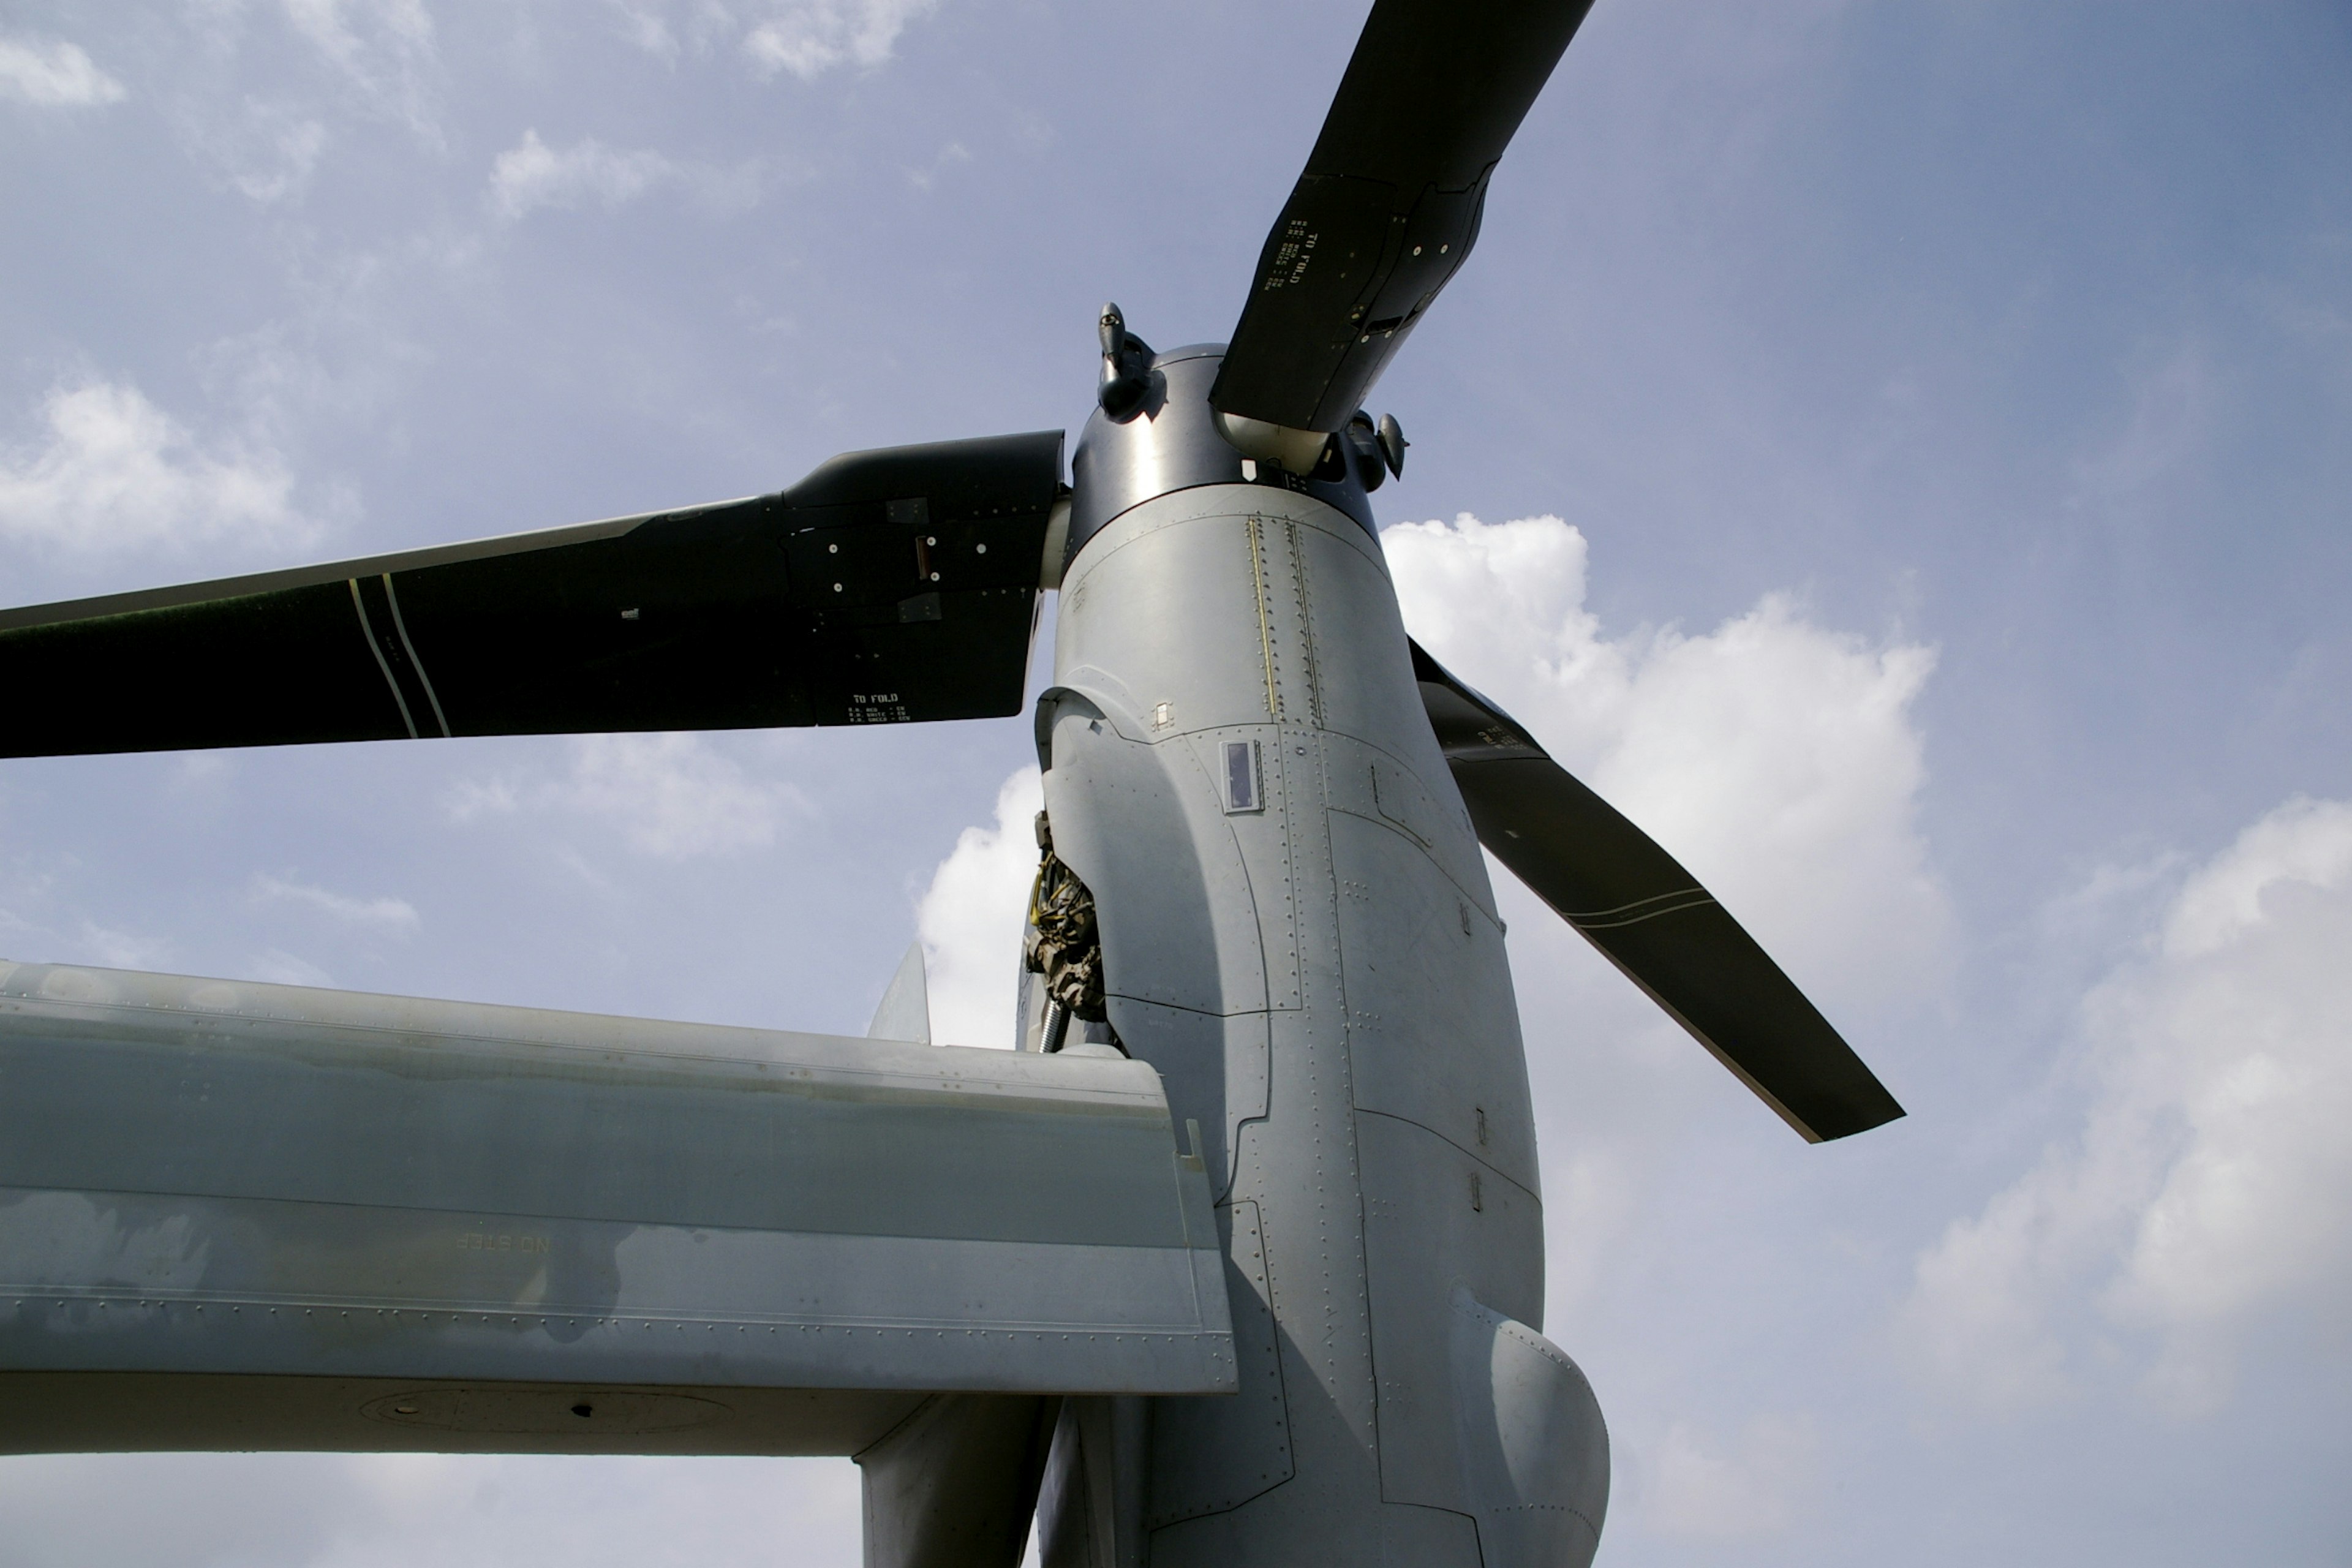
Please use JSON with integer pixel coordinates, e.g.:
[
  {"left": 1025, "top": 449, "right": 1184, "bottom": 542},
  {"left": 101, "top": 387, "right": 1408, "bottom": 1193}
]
[{"left": 1414, "top": 644, "right": 1903, "bottom": 1142}]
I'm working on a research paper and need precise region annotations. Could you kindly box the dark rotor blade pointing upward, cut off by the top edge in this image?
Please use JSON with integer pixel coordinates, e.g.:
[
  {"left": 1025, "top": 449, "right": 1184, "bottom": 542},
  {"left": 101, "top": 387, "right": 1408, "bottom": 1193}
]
[{"left": 1209, "top": 0, "right": 1593, "bottom": 430}]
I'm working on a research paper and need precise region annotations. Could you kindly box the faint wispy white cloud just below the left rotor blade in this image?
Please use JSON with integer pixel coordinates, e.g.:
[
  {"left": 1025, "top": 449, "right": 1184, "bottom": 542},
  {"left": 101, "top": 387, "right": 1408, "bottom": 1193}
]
[{"left": 442, "top": 733, "right": 807, "bottom": 861}]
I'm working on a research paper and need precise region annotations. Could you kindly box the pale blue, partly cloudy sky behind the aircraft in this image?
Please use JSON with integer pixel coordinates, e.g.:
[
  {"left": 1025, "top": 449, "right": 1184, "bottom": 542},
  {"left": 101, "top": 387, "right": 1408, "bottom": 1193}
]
[{"left": 0, "top": 0, "right": 2352, "bottom": 1568}]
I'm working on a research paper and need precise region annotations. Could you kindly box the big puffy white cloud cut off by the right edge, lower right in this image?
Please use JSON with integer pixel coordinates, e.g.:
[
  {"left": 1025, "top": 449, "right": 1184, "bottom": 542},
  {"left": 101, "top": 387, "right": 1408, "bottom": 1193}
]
[{"left": 1901, "top": 799, "right": 2352, "bottom": 1415}]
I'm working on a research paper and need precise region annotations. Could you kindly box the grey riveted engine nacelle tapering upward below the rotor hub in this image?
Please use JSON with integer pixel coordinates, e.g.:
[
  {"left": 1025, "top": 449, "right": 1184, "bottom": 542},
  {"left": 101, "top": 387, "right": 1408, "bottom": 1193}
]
[{"left": 1037, "top": 350, "right": 1607, "bottom": 1568}]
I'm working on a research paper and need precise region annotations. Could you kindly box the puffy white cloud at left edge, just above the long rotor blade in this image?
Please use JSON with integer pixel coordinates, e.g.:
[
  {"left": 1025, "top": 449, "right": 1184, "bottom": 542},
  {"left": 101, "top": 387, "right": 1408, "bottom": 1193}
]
[{"left": 0, "top": 381, "right": 317, "bottom": 555}]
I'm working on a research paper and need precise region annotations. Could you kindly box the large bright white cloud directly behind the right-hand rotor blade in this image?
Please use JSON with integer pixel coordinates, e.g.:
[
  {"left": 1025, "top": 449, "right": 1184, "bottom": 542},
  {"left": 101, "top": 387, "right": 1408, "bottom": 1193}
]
[{"left": 1381, "top": 515, "right": 1954, "bottom": 1004}]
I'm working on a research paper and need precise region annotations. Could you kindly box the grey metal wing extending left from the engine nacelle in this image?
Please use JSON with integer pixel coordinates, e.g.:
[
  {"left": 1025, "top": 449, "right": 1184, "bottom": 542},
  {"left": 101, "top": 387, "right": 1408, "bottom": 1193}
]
[{"left": 0, "top": 964, "right": 1235, "bottom": 1453}]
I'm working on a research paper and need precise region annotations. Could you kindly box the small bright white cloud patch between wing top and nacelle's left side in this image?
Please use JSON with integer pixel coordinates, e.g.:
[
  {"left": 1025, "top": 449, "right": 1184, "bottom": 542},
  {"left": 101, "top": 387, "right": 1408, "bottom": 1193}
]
[{"left": 915, "top": 769, "right": 1044, "bottom": 1046}]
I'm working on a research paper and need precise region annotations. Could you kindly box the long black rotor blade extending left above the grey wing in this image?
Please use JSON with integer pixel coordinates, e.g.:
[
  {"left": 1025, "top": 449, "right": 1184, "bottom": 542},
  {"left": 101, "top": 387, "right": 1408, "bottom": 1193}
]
[{"left": 0, "top": 430, "right": 1061, "bottom": 757}]
